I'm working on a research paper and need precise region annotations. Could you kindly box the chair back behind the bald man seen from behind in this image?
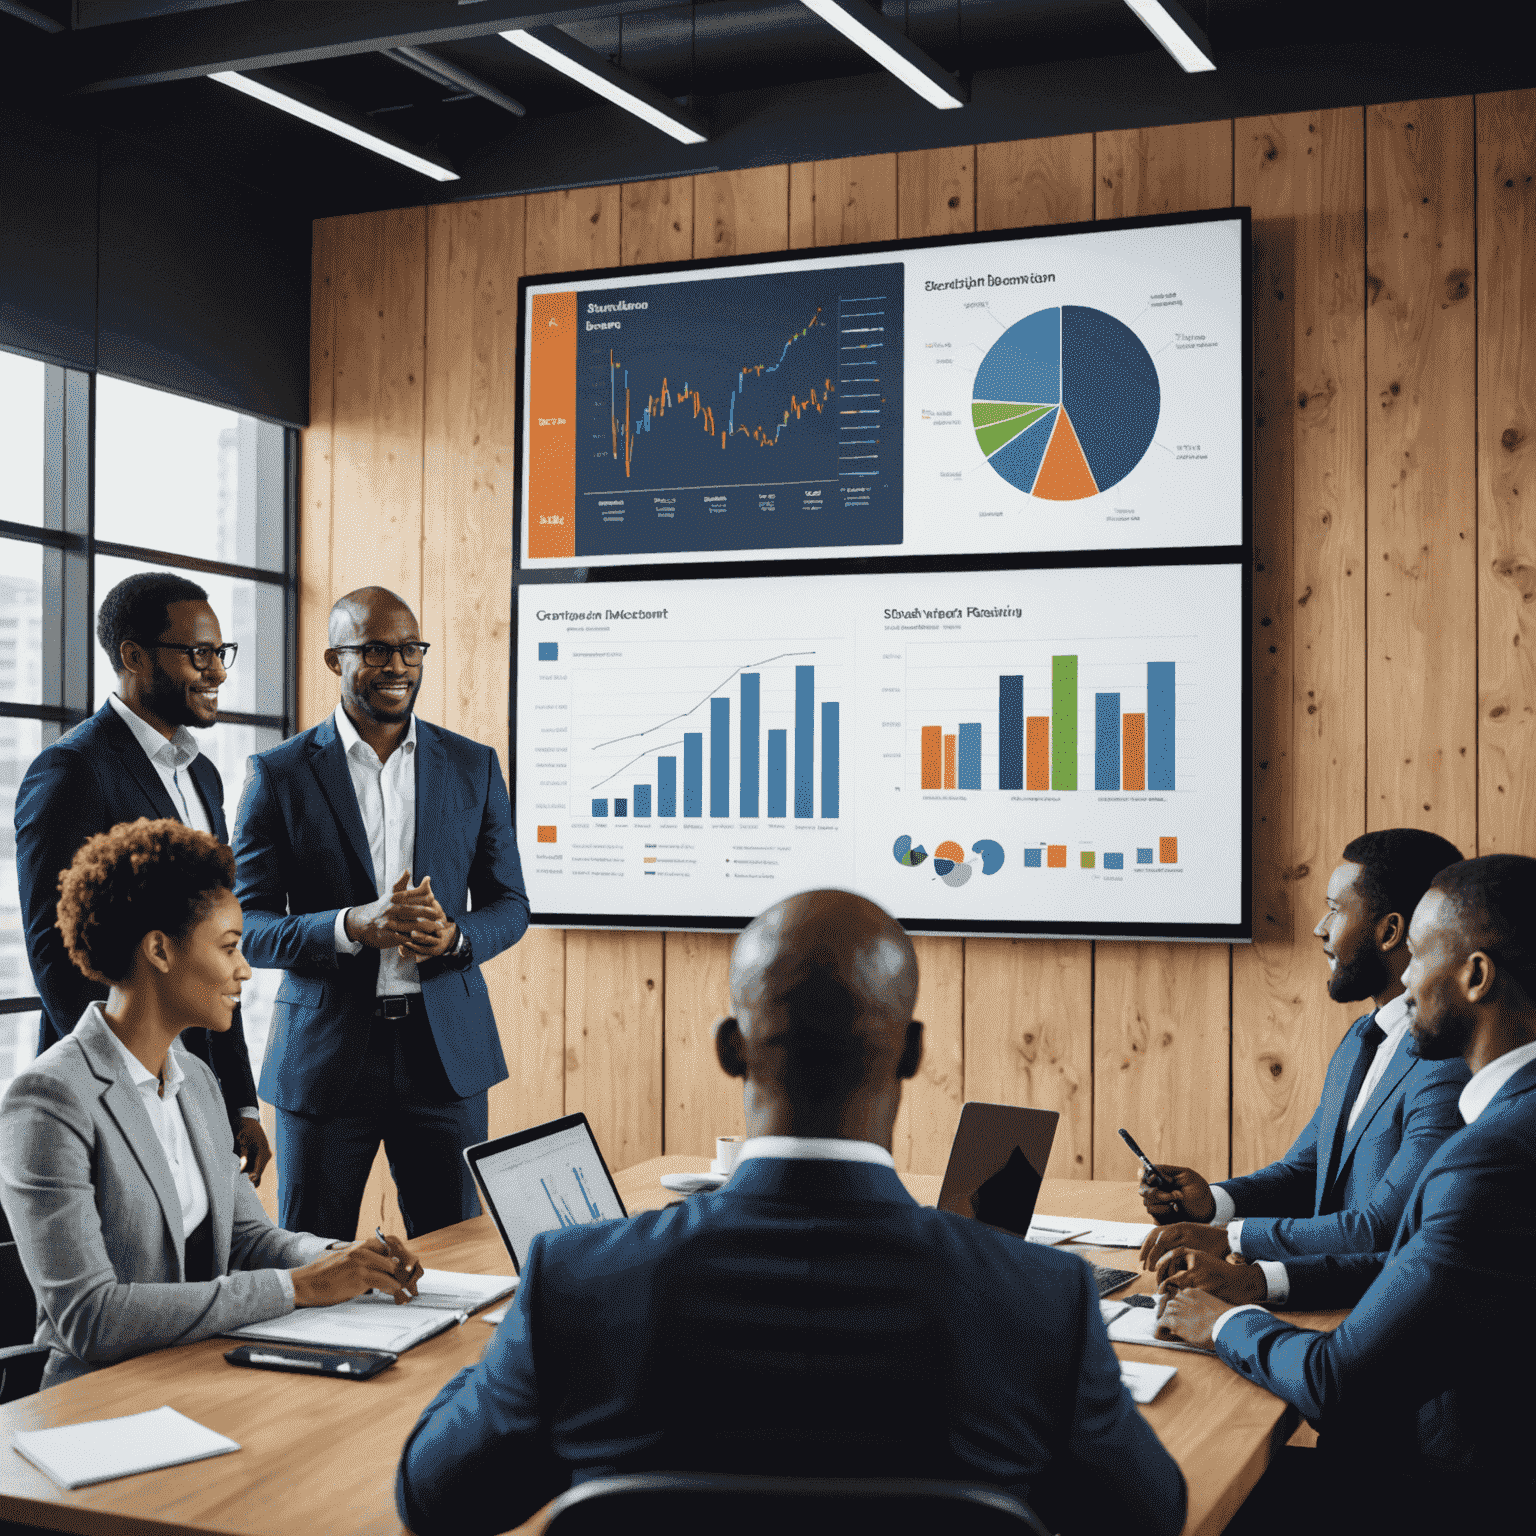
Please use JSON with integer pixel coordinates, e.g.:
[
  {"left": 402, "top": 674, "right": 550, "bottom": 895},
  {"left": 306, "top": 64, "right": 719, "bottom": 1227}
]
[{"left": 544, "top": 1471, "right": 1049, "bottom": 1536}]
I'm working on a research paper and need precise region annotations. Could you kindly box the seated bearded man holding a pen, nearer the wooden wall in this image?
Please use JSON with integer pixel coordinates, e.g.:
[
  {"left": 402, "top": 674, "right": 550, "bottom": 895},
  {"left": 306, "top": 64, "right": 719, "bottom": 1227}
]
[{"left": 1141, "top": 826, "right": 1467, "bottom": 1306}]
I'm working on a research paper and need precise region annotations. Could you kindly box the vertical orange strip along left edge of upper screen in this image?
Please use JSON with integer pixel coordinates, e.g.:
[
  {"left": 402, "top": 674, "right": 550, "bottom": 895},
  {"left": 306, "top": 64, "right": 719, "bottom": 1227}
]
[{"left": 524, "top": 293, "right": 578, "bottom": 561}]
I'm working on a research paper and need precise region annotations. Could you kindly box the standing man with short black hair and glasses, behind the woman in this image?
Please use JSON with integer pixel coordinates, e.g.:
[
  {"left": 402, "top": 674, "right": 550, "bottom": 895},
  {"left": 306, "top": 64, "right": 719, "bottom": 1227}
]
[{"left": 15, "top": 571, "right": 272, "bottom": 1184}]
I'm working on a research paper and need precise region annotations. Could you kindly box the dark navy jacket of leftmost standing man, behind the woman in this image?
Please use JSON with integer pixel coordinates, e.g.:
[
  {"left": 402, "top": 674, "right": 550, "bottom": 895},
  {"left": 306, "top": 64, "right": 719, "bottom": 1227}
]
[{"left": 15, "top": 703, "right": 257, "bottom": 1117}]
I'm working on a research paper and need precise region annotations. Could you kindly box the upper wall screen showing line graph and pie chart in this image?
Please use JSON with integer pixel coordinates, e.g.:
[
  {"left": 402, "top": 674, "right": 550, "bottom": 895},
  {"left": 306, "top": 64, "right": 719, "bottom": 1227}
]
[{"left": 518, "top": 209, "right": 1247, "bottom": 570}]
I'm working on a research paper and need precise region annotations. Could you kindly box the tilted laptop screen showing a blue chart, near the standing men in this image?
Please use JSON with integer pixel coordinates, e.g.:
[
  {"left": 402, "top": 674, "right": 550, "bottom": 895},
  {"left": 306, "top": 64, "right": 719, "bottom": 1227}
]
[{"left": 464, "top": 1114, "right": 627, "bottom": 1273}]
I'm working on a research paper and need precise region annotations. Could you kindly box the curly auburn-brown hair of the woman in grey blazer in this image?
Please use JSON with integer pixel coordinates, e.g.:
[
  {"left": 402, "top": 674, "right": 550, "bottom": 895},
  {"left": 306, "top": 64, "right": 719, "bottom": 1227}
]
[{"left": 58, "top": 817, "right": 235, "bottom": 986}]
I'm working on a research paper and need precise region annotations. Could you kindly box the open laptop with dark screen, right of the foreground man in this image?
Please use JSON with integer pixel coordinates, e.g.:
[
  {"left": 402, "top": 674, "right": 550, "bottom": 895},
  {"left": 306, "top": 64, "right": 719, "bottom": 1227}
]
[{"left": 938, "top": 1103, "right": 1137, "bottom": 1296}]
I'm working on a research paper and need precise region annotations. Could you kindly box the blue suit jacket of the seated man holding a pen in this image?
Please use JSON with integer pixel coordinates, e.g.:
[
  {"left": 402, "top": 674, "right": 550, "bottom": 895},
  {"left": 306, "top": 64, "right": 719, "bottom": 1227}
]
[{"left": 1223, "top": 1014, "right": 1468, "bottom": 1259}]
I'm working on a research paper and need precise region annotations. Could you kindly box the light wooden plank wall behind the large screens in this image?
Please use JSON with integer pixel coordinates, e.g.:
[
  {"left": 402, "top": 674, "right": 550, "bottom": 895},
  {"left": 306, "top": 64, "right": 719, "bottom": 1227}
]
[{"left": 285, "top": 92, "right": 1536, "bottom": 1221}]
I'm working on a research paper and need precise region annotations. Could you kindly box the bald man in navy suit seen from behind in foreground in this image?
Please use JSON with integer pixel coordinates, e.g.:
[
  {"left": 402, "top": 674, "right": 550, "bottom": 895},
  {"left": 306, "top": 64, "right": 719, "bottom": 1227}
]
[{"left": 395, "top": 891, "right": 1186, "bottom": 1536}]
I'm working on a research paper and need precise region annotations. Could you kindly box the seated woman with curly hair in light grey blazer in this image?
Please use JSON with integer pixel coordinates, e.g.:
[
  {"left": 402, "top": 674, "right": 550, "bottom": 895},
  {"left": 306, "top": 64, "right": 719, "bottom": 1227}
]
[{"left": 0, "top": 820, "right": 421, "bottom": 1387}]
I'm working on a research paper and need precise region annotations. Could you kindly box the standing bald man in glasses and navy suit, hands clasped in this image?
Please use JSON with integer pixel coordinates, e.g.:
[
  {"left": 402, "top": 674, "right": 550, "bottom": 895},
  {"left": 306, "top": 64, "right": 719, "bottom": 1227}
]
[{"left": 235, "top": 587, "right": 528, "bottom": 1241}]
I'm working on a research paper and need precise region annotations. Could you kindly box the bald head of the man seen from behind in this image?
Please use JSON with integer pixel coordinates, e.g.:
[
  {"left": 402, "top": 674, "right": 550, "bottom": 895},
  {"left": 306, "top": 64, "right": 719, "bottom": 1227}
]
[{"left": 716, "top": 891, "right": 922, "bottom": 1146}]
